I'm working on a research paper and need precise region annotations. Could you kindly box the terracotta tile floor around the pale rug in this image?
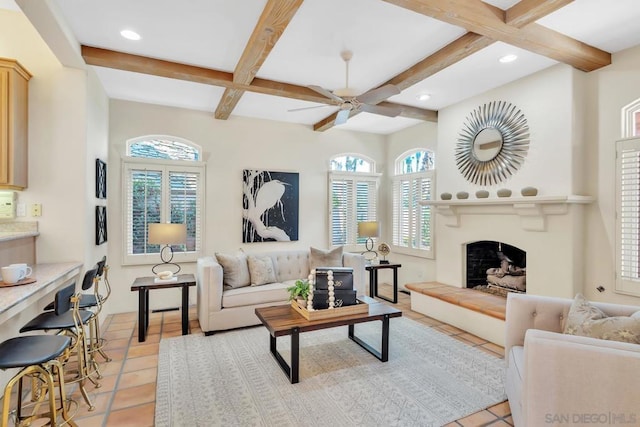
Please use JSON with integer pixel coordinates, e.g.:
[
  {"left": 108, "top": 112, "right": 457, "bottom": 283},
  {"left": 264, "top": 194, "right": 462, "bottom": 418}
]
[{"left": 58, "top": 285, "right": 513, "bottom": 427}]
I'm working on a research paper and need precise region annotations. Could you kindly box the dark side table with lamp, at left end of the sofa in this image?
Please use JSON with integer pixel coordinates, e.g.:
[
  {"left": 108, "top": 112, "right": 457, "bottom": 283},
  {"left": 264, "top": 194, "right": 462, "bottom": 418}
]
[{"left": 131, "top": 274, "right": 196, "bottom": 342}]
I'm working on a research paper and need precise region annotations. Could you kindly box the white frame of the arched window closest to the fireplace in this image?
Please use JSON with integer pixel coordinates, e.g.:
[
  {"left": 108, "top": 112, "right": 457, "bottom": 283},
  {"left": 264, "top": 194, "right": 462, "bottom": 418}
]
[{"left": 391, "top": 148, "right": 436, "bottom": 259}]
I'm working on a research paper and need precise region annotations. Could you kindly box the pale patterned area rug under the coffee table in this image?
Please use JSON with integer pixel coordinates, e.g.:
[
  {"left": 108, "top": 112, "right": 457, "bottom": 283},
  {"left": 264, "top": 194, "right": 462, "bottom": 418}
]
[{"left": 155, "top": 318, "right": 506, "bottom": 427}]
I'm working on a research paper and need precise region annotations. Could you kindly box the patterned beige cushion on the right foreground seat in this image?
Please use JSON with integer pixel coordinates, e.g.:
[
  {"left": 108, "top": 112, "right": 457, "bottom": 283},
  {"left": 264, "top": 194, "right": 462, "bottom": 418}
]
[{"left": 564, "top": 294, "right": 640, "bottom": 344}]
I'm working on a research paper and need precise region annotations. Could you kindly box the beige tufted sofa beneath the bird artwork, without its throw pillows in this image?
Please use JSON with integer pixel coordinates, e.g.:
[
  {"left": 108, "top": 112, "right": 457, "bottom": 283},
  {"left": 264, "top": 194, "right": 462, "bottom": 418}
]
[{"left": 196, "top": 250, "right": 366, "bottom": 335}]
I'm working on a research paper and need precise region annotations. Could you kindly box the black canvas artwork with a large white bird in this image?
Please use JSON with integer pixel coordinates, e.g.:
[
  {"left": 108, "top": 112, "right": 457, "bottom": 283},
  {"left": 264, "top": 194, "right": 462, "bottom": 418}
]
[{"left": 242, "top": 169, "right": 299, "bottom": 243}]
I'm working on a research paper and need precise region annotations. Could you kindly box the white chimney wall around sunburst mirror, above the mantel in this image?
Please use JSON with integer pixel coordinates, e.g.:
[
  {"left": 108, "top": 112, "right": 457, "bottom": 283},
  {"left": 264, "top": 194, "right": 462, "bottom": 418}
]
[{"left": 437, "top": 65, "right": 574, "bottom": 197}]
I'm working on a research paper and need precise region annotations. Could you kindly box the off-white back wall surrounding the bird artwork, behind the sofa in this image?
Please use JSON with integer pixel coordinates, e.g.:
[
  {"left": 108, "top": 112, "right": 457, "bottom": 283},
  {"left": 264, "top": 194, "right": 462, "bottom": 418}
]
[{"left": 107, "top": 100, "right": 385, "bottom": 312}]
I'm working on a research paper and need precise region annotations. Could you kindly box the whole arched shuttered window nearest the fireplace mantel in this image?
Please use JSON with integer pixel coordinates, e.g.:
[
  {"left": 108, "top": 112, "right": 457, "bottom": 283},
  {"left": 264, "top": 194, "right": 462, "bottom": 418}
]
[{"left": 392, "top": 149, "right": 435, "bottom": 257}]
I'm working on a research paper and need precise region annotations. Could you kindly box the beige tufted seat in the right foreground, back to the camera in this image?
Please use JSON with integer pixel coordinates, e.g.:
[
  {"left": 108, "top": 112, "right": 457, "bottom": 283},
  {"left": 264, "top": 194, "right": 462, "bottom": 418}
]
[{"left": 505, "top": 294, "right": 640, "bottom": 427}]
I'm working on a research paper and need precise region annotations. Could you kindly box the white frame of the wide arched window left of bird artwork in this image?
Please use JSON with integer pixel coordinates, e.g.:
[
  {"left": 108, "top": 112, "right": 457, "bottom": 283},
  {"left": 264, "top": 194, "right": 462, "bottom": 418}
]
[{"left": 121, "top": 137, "right": 206, "bottom": 265}]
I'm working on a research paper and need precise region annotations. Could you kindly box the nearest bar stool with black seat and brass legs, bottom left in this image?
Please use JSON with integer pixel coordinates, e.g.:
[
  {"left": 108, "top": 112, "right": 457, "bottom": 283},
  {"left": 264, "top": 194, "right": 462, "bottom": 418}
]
[{"left": 0, "top": 335, "right": 75, "bottom": 426}]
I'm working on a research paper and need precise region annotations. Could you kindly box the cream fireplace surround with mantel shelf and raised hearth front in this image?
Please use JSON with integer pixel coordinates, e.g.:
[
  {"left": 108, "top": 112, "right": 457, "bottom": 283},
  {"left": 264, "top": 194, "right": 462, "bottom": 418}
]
[{"left": 411, "top": 196, "right": 593, "bottom": 345}]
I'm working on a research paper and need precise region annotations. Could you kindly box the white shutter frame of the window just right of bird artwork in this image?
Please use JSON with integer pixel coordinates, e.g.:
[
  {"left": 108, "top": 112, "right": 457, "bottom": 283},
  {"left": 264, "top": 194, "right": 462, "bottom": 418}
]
[{"left": 327, "top": 170, "right": 381, "bottom": 250}]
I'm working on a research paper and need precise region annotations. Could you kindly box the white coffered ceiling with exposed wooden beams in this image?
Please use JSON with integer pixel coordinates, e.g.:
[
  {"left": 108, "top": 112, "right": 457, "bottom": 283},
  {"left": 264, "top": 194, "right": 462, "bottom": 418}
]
[{"left": 5, "top": 0, "right": 640, "bottom": 134}]
